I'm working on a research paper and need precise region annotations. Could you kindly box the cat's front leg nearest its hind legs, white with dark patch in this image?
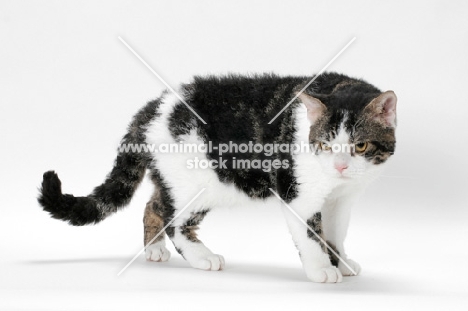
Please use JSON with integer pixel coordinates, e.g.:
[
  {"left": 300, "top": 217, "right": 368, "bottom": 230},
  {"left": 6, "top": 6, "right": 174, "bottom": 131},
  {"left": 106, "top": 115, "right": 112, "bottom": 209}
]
[{"left": 284, "top": 200, "right": 342, "bottom": 283}]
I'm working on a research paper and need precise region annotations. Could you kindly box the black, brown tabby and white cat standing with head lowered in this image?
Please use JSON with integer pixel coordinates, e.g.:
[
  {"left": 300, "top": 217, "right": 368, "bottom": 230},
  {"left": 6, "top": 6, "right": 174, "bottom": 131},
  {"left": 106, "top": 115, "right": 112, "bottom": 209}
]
[{"left": 38, "top": 72, "right": 397, "bottom": 283}]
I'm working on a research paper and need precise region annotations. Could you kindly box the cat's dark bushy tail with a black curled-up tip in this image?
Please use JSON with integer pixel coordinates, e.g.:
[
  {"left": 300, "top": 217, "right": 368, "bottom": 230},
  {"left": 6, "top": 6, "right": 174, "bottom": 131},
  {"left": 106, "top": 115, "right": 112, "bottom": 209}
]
[{"left": 38, "top": 99, "right": 160, "bottom": 226}]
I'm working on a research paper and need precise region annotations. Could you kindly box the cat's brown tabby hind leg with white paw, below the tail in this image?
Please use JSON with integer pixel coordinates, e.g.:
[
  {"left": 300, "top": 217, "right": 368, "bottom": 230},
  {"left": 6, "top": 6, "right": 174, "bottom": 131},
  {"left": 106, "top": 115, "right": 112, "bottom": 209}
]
[{"left": 143, "top": 195, "right": 171, "bottom": 261}]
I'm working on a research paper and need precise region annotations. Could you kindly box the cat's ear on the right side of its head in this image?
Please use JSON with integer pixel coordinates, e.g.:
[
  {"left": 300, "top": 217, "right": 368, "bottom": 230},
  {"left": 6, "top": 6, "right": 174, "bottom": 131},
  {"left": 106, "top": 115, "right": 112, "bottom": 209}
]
[{"left": 364, "top": 91, "right": 397, "bottom": 127}]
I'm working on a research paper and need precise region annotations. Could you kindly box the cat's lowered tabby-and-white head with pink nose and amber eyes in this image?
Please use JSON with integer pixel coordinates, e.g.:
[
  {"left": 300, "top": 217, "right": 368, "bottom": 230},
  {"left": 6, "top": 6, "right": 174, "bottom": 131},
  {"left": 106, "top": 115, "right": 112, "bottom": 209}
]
[{"left": 299, "top": 83, "right": 397, "bottom": 178}]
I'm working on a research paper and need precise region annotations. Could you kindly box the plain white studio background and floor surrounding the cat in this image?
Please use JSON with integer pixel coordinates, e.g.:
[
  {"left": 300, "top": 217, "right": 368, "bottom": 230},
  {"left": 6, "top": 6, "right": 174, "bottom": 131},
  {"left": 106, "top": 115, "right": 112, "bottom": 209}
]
[{"left": 0, "top": 1, "right": 468, "bottom": 310}]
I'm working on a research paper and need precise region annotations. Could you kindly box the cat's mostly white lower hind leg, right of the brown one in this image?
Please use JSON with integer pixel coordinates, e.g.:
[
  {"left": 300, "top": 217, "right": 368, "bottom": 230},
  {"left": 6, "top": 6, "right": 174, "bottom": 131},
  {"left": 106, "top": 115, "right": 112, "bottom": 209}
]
[{"left": 166, "top": 209, "right": 224, "bottom": 271}]
